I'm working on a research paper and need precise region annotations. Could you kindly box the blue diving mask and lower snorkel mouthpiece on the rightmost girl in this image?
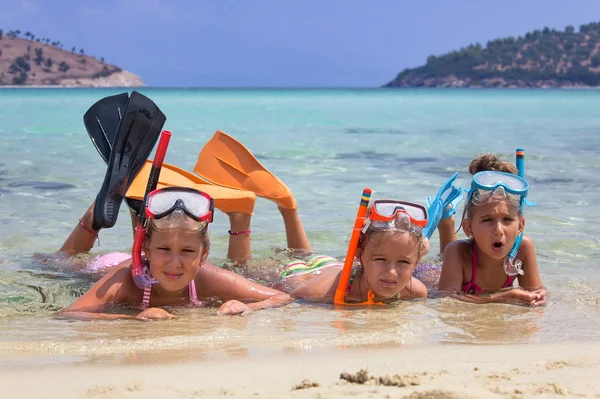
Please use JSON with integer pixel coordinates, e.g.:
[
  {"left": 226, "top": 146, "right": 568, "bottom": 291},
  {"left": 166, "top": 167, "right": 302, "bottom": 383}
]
[{"left": 467, "top": 170, "right": 529, "bottom": 276}]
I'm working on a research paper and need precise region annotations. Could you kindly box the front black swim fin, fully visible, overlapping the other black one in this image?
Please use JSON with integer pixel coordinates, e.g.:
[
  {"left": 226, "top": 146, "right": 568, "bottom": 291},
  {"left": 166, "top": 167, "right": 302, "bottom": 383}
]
[{"left": 91, "top": 91, "right": 167, "bottom": 230}]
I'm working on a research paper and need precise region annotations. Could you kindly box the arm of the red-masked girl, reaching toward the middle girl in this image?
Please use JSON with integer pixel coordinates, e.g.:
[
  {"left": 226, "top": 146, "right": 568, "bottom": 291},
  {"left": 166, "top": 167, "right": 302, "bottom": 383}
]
[{"left": 195, "top": 263, "right": 291, "bottom": 314}]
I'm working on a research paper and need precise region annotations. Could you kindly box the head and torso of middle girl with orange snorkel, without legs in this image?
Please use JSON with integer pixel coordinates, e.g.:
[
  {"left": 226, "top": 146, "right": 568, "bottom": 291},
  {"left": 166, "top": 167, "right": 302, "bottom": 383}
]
[{"left": 277, "top": 200, "right": 428, "bottom": 304}]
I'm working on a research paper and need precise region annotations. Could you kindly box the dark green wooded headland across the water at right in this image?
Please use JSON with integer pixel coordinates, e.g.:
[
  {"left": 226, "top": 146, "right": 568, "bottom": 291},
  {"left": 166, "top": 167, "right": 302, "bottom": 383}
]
[{"left": 383, "top": 22, "right": 600, "bottom": 88}]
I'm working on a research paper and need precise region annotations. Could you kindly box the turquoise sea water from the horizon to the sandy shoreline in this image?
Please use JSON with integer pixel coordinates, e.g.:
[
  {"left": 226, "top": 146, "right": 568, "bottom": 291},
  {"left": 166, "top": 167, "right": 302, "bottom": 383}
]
[{"left": 0, "top": 88, "right": 600, "bottom": 369}]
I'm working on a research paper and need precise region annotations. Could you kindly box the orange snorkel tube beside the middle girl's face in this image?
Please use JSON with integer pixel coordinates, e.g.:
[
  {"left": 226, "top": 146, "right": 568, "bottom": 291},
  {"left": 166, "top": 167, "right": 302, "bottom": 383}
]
[{"left": 333, "top": 188, "right": 382, "bottom": 305}]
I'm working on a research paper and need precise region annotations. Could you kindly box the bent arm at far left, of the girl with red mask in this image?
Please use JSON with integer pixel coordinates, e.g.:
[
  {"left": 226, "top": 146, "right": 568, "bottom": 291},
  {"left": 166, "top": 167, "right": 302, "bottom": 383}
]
[{"left": 59, "top": 260, "right": 174, "bottom": 320}]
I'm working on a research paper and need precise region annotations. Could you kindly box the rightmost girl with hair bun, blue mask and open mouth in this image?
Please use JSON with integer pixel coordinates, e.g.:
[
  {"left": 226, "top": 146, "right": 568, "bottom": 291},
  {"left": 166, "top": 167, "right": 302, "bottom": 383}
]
[{"left": 438, "top": 150, "right": 547, "bottom": 306}]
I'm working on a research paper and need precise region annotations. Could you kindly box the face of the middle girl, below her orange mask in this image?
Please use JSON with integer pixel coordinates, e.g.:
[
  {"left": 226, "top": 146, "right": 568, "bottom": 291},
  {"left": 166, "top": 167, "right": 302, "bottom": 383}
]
[{"left": 359, "top": 231, "right": 419, "bottom": 298}]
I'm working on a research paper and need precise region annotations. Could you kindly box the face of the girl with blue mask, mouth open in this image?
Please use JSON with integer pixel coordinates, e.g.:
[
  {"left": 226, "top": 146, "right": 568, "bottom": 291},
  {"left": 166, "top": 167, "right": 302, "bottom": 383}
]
[{"left": 463, "top": 198, "right": 525, "bottom": 260}]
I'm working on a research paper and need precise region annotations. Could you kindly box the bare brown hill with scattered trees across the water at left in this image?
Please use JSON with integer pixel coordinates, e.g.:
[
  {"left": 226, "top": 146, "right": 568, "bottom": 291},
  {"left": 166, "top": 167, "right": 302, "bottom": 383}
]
[{"left": 0, "top": 29, "right": 144, "bottom": 87}]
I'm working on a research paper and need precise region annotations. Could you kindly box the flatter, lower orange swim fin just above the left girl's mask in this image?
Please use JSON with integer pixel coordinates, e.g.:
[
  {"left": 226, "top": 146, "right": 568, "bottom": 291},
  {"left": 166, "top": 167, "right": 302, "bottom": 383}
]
[{"left": 126, "top": 160, "right": 256, "bottom": 215}]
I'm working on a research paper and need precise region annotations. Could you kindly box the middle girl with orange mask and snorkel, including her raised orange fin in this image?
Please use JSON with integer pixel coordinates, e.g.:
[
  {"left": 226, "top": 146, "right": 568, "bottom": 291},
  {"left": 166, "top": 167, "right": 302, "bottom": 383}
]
[{"left": 195, "top": 132, "right": 428, "bottom": 302}]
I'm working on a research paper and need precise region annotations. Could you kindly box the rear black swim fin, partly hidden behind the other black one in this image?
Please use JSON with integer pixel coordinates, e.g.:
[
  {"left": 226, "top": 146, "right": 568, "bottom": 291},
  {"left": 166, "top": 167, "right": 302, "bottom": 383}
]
[{"left": 83, "top": 93, "right": 129, "bottom": 163}]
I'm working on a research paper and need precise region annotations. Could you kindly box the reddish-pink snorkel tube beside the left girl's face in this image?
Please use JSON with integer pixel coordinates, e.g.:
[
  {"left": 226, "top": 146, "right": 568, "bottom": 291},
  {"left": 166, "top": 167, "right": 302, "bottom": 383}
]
[{"left": 131, "top": 130, "right": 171, "bottom": 290}]
